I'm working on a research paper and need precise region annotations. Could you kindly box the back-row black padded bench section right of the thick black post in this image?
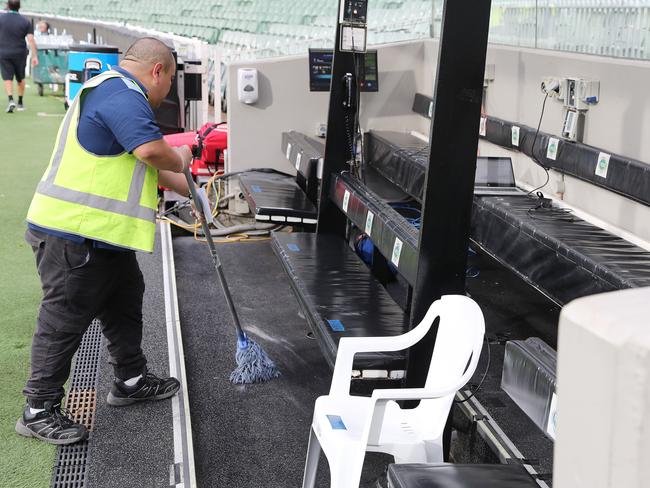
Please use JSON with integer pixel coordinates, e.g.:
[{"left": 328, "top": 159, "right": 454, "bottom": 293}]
[{"left": 472, "top": 197, "right": 650, "bottom": 304}]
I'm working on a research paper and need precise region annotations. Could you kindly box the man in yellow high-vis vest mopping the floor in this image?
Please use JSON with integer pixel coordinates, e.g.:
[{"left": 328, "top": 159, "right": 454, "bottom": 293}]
[{"left": 16, "top": 38, "right": 192, "bottom": 444}]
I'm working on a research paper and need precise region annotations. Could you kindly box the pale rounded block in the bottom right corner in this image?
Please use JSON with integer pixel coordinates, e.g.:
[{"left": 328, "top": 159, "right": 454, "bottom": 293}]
[{"left": 553, "top": 288, "right": 650, "bottom": 488}]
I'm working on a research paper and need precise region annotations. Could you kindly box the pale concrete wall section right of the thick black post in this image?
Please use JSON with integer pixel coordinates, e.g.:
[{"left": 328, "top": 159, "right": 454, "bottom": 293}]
[{"left": 470, "top": 45, "right": 650, "bottom": 244}]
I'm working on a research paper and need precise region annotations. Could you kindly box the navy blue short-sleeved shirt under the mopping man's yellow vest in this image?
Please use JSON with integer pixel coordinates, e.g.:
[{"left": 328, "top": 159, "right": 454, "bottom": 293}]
[{"left": 28, "top": 66, "right": 162, "bottom": 250}]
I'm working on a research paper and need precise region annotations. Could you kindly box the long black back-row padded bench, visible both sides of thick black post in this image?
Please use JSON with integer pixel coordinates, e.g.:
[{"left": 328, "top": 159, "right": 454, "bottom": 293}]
[{"left": 368, "top": 127, "right": 650, "bottom": 304}]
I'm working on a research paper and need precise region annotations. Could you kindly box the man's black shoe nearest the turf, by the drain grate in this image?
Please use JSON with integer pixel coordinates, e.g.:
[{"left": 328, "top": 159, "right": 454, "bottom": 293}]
[{"left": 16, "top": 402, "right": 88, "bottom": 445}]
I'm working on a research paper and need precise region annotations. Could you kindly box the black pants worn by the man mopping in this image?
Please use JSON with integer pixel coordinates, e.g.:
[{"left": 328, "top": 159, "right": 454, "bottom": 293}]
[{"left": 23, "top": 229, "right": 147, "bottom": 408}]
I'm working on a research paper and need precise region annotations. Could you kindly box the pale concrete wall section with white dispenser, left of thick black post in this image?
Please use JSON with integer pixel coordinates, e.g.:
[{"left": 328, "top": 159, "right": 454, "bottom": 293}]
[{"left": 227, "top": 41, "right": 437, "bottom": 172}]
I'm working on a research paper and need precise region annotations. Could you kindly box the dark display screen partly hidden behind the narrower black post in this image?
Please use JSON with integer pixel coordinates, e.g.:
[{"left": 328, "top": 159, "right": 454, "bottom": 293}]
[{"left": 309, "top": 49, "right": 379, "bottom": 92}]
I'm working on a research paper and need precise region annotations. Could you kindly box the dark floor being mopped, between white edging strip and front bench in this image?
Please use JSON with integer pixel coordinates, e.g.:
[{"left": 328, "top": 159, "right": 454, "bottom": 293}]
[{"left": 174, "top": 237, "right": 390, "bottom": 488}]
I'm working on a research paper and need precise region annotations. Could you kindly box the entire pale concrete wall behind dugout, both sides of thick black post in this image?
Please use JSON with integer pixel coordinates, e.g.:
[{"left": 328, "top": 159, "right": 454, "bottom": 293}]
[{"left": 228, "top": 39, "right": 650, "bottom": 243}]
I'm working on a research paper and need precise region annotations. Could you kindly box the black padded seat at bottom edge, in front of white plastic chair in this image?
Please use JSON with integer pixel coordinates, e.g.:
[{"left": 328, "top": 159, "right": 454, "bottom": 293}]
[{"left": 388, "top": 464, "right": 539, "bottom": 488}]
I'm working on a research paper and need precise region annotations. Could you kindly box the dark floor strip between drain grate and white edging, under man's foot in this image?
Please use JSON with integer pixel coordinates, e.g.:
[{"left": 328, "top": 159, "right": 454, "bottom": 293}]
[{"left": 87, "top": 232, "right": 174, "bottom": 488}]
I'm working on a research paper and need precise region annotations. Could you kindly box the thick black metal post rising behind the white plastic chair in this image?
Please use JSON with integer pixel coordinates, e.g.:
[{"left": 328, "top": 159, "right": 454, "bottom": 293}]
[{"left": 407, "top": 0, "right": 490, "bottom": 387}]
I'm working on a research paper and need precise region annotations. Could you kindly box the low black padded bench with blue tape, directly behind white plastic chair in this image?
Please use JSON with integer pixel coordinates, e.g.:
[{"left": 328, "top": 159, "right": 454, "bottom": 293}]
[{"left": 272, "top": 232, "right": 409, "bottom": 379}]
